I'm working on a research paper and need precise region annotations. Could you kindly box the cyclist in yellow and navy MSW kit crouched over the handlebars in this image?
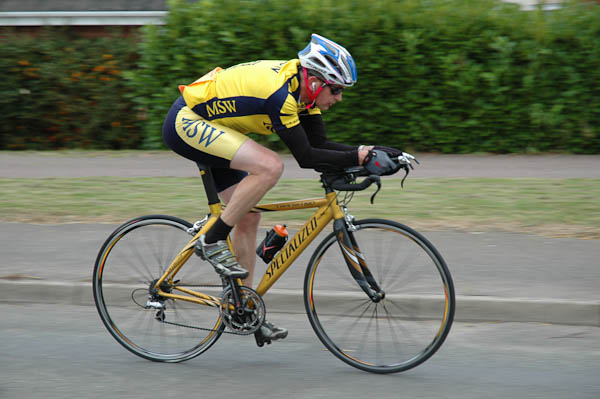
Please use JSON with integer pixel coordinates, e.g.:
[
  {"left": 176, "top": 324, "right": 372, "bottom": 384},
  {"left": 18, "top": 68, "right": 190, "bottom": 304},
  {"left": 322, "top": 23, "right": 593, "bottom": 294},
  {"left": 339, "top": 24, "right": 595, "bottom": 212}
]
[{"left": 163, "top": 34, "right": 410, "bottom": 340}]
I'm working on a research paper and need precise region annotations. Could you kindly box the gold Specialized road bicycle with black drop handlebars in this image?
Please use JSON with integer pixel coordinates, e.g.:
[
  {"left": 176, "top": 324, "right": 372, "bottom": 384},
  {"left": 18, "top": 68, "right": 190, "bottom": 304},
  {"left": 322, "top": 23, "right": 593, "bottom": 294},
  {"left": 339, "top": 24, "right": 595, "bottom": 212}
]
[{"left": 93, "top": 160, "right": 456, "bottom": 373}]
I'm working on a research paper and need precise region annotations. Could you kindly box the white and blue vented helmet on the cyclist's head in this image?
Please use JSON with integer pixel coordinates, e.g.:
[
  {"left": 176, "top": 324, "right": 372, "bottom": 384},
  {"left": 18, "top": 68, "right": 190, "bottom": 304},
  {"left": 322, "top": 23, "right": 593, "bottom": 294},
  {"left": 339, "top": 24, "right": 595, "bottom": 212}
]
[{"left": 298, "top": 33, "right": 357, "bottom": 87}]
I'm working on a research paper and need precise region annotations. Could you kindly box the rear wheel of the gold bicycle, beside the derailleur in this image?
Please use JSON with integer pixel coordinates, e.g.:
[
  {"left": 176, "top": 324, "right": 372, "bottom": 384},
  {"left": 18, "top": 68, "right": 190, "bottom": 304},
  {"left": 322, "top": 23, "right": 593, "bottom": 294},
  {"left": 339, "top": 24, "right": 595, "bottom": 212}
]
[{"left": 92, "top": 215, "right": 224, "bottom": 362}]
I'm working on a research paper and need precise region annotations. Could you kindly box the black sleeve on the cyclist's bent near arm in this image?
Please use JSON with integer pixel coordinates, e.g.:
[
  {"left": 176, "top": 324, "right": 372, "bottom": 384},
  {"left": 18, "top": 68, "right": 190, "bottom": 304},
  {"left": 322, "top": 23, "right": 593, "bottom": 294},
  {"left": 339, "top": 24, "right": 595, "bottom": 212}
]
[{"left": 277, "top": 119, "right": 358, "bottom": 169}]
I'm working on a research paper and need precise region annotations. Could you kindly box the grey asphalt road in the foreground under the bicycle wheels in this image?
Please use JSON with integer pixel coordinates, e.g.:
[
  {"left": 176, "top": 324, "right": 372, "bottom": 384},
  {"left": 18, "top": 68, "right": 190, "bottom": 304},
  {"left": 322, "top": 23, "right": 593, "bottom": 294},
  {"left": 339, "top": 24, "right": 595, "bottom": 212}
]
[{"left": 0, "top": 305, "right": 600, "bottom": 399}]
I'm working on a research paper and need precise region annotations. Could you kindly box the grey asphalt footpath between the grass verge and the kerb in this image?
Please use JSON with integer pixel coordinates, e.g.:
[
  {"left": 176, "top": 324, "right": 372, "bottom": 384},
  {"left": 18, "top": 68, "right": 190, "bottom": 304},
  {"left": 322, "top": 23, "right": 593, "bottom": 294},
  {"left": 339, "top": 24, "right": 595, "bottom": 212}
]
[{"left": 0, "top": 223, "right": 600, "bottom": 306}]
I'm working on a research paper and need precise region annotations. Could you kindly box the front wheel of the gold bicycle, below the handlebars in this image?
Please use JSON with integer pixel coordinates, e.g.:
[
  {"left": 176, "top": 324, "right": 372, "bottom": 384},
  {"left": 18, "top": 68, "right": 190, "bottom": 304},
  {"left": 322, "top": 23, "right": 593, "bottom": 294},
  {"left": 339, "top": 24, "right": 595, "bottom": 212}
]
[{"left": 304, "top": 219, "right": 456, "bottom": 374}]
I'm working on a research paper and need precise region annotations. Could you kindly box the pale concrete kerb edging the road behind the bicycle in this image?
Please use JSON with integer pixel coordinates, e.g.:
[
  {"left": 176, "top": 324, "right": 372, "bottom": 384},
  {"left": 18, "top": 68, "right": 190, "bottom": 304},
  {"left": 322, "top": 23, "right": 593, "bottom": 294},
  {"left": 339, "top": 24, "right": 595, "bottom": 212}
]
[{"left": 0, "top": 281, "right": 600, "bottom": 327}]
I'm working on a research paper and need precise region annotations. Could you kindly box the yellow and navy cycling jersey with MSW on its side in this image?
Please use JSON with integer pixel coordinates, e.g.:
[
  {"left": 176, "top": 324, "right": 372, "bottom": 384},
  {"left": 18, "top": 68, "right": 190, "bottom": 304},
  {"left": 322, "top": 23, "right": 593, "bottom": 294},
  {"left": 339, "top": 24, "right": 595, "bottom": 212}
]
[{"left": 179, "top": 59, "right": 321, "bottom": 134}]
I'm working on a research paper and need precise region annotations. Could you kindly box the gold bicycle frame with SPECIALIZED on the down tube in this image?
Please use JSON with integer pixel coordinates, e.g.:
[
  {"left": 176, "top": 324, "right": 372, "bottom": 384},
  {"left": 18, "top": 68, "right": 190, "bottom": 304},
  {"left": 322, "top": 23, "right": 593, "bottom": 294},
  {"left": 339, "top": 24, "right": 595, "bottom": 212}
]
[{"left": 155, "top": 192, "right": 344, "bottom": 307}]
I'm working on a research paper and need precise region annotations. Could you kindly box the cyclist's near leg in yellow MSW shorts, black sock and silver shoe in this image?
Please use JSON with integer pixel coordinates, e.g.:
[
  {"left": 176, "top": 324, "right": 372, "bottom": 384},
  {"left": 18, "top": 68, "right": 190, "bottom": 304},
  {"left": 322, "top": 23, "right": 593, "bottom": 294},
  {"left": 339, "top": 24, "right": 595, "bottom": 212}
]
[{"left": 163, "top": 98, "right": 268, "bottom": 278}]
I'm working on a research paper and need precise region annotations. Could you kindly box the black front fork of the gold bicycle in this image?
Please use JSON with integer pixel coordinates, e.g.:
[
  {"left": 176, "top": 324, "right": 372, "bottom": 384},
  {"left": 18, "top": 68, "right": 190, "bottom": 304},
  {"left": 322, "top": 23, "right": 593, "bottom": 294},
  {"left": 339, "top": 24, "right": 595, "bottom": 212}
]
[{"left": 333, "top": 219, "right": 385, "bottom": 303}]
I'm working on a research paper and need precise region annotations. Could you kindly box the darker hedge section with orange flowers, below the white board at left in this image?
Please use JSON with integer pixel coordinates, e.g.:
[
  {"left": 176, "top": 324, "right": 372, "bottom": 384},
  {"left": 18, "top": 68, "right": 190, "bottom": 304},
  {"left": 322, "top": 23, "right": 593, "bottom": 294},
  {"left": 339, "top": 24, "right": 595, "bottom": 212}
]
[{"left": 0, "top": 28, "right": 144, "bottom": 150}]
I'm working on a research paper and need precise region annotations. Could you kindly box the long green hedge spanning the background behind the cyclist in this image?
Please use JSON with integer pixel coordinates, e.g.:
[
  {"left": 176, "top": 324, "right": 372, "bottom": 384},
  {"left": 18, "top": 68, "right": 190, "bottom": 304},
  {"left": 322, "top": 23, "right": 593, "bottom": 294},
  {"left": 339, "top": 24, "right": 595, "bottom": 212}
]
[{"left": 0, "top": 0, "right": 600, "bottom": 153}]
